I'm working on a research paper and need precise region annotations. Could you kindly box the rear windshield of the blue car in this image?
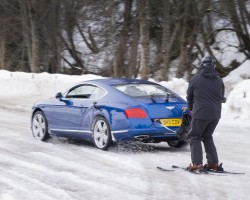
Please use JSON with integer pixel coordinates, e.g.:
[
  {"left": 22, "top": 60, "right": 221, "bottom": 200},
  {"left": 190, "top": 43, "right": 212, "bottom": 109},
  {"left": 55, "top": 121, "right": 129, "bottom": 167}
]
[{"left": 114, "top": 84, "right": 178, "bottom": 98}]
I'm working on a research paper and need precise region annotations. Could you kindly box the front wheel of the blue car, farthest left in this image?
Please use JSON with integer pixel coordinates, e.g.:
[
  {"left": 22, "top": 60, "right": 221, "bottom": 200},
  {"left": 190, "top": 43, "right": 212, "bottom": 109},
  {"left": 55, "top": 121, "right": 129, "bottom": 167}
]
[{"left": 31, "top": 111, "right": 49, "bottom": 141}]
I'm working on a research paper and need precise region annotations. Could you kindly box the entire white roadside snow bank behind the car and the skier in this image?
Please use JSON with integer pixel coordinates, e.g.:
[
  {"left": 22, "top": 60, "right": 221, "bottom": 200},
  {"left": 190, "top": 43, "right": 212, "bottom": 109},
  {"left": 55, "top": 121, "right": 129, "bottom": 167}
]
[{"left": 0, "top": 64, "right": 250, "bottom": 121}]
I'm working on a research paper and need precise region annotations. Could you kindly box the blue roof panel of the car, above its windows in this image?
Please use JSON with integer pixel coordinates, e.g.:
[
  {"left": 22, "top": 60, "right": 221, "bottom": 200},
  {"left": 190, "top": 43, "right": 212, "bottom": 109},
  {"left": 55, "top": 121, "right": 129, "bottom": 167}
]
[{"left": 87, "top": 78, "right": 156, "bottom": 85}]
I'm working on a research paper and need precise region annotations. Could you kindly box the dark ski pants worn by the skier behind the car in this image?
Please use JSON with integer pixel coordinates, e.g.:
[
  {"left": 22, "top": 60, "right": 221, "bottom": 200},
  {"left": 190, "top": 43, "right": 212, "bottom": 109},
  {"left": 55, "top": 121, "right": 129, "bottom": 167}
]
[{"left": 189, "top": 119, "right": 219, "bottom": 165}]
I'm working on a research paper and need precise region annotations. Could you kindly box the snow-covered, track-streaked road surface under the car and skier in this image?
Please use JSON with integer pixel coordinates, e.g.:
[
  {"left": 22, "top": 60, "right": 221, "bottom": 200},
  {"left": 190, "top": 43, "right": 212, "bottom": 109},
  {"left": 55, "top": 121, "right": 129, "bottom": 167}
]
[{"left": 0, "top": 109, "right": 250, "bottom": 200}]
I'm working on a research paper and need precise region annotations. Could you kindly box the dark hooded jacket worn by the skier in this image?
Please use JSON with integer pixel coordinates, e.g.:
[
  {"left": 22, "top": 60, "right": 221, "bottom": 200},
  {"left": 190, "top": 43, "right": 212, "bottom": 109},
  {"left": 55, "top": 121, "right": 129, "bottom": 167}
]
[{"left": 187, "top": 66, "right": 225, "bottom": 120}]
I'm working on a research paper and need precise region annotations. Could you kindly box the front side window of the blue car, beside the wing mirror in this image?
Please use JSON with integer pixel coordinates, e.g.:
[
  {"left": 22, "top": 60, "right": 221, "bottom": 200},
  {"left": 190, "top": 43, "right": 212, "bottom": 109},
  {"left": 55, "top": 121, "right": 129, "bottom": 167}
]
[{"left": 66, "top": 85, "right": 97, "bottom": 99}]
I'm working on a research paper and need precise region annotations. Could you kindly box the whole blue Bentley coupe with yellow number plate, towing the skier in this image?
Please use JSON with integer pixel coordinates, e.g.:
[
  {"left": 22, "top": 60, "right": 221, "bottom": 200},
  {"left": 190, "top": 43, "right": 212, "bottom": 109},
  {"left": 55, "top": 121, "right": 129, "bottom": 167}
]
[{"left": 31, "top": 78, "right": 186, "bottom": 150}]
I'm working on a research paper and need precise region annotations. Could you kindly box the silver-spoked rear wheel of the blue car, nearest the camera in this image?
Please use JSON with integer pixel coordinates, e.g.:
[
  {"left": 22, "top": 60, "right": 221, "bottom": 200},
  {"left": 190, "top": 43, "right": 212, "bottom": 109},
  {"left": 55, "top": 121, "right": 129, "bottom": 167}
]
[{"left": 92, "top": 116, "right": 112, "bottom": 150}]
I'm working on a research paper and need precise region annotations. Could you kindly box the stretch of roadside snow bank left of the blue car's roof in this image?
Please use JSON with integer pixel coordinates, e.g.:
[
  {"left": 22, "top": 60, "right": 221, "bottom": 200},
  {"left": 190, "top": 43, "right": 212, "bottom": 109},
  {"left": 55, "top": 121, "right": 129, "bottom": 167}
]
[{"left": 0, "top": 70, "right": 101, "bottom": 110}]
